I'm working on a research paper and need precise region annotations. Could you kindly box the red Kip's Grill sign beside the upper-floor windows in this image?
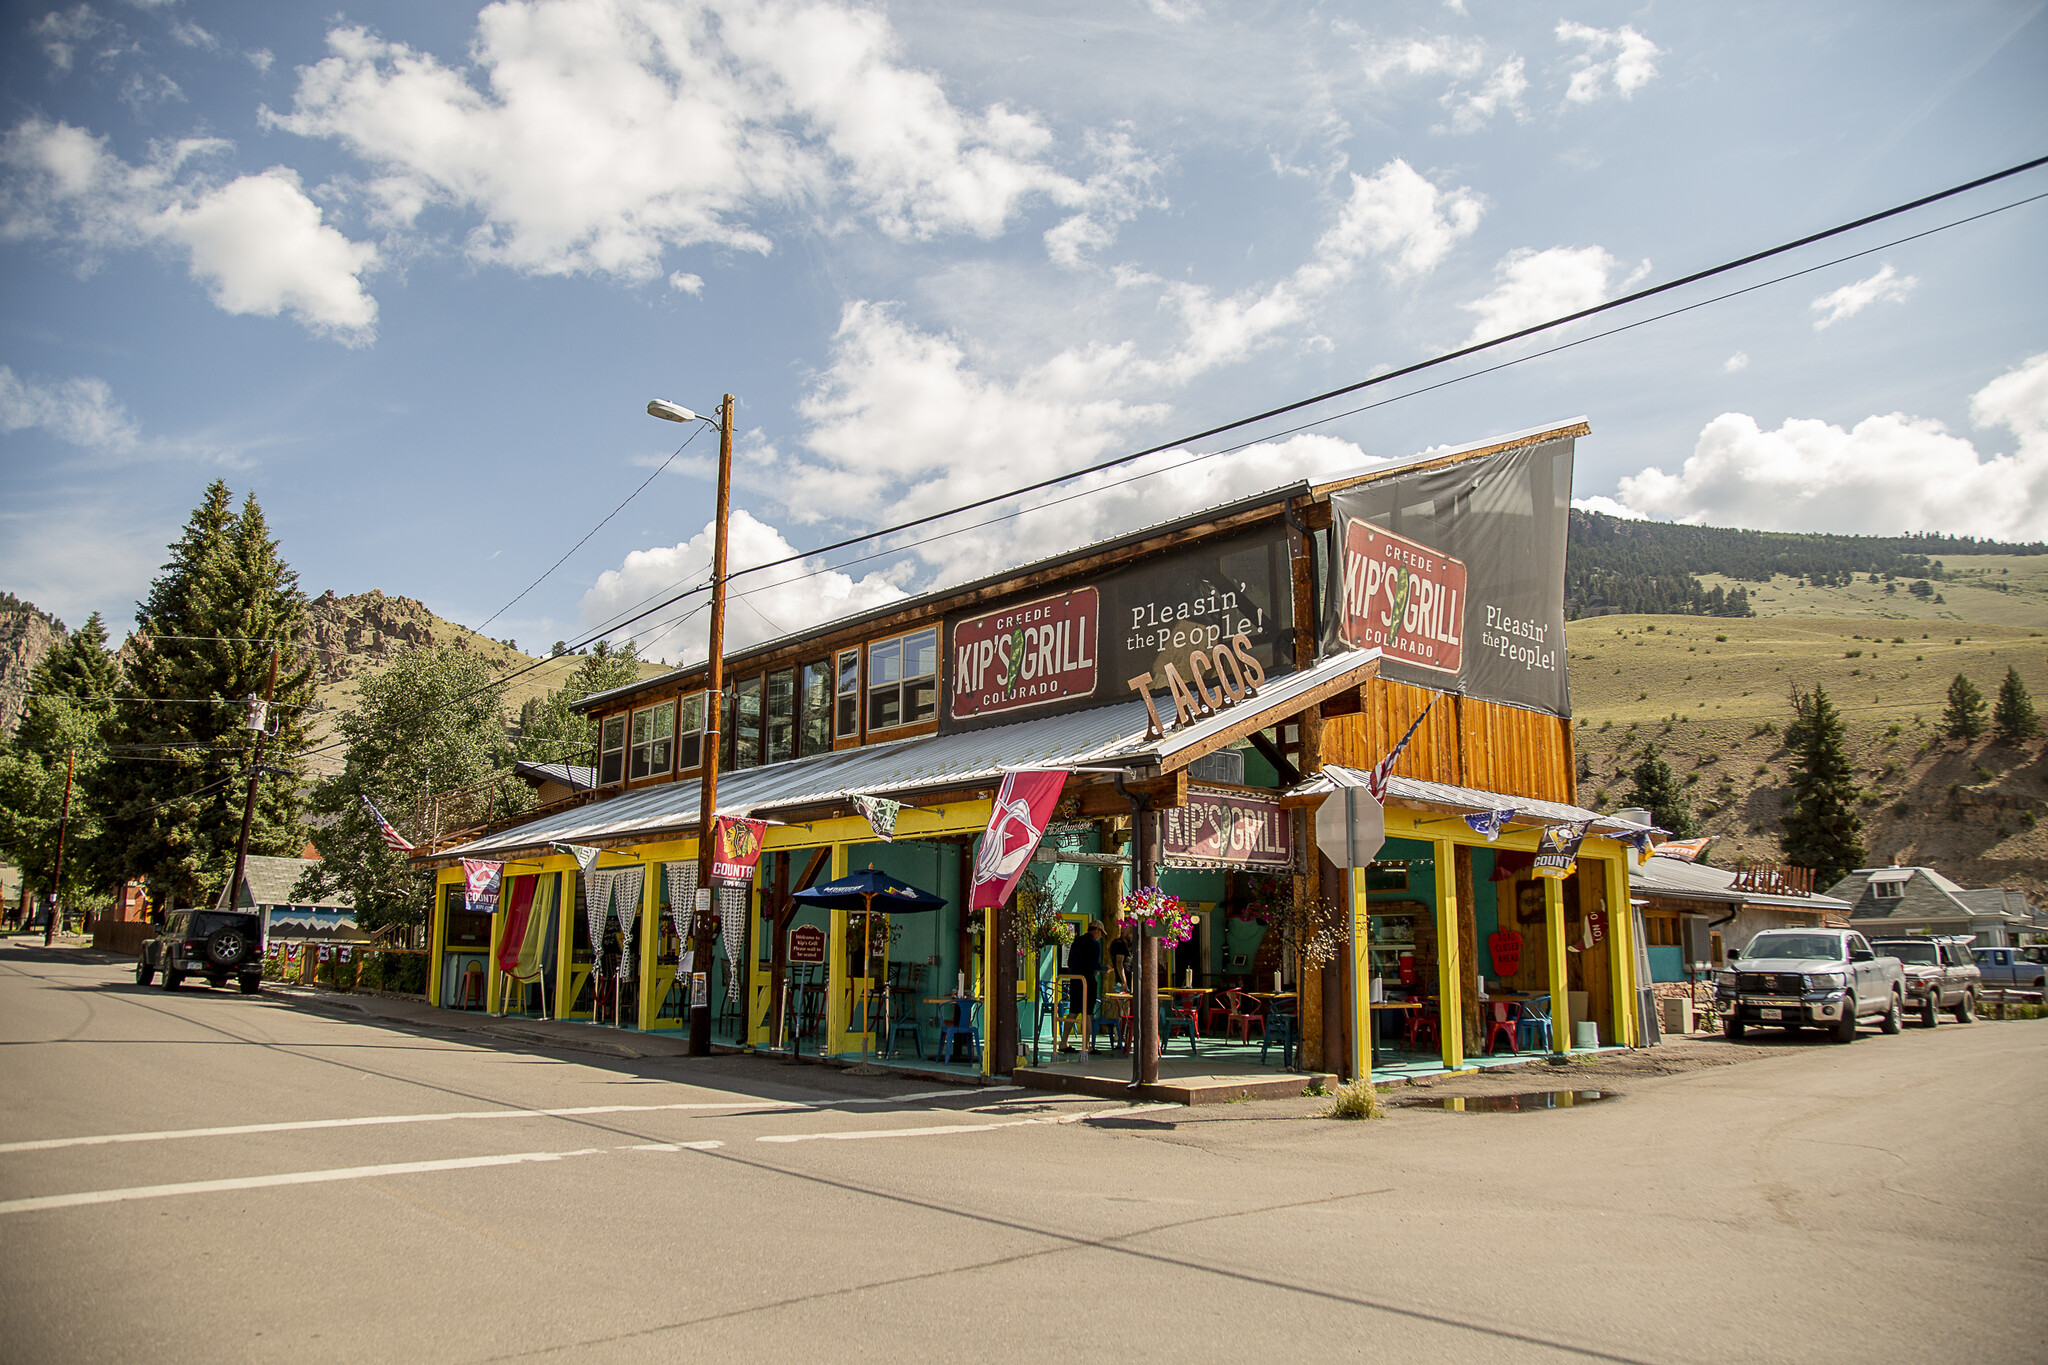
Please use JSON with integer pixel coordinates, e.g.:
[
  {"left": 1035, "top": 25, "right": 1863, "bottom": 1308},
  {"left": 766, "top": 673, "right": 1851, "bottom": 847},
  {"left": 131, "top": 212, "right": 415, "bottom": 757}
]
[{"left": 952, "top": 587, "right": 1102, "bottom": 720}]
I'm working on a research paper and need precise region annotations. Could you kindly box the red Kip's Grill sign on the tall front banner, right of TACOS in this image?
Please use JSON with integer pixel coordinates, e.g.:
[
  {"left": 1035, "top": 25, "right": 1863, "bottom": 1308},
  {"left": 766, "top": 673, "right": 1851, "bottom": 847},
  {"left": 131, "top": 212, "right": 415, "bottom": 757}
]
[{"left": 1343, "top": 520, "right": 1464, "bottom": 673}]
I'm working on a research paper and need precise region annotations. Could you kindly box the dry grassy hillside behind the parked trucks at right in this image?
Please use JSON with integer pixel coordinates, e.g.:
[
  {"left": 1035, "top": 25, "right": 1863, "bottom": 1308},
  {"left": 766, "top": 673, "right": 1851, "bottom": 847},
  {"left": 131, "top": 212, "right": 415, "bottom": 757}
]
[{"left": 1567, "top": 555, "right": 2048, "bottom": 900}]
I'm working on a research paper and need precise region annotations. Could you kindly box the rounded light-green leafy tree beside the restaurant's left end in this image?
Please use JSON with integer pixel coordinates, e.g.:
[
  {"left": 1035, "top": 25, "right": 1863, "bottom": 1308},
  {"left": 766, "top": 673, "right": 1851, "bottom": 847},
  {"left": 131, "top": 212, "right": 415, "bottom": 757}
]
[{"left": 293, "top": 645, "right": 516, "bottom": 929}]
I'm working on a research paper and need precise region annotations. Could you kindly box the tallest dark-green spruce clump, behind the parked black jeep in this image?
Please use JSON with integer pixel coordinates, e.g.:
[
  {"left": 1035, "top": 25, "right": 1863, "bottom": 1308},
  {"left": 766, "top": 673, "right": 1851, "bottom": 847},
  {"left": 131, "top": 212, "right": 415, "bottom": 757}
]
[{"left": 90, "top": 479, "right": 313, "bottom": 905}]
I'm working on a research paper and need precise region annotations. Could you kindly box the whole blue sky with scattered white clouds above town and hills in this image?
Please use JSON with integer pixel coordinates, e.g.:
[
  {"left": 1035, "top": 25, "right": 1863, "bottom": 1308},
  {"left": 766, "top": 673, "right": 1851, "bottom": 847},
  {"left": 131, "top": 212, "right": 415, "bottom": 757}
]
[{"left": 0, "top": 0, "right": 2048, "bottom": 657}]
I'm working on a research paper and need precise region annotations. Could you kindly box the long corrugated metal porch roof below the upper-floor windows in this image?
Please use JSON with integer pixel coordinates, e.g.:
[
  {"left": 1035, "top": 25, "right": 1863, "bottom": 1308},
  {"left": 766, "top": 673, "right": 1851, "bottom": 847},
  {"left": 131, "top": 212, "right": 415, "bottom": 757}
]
[{"left": 434, "top": 649, "right": 1378, "bottom": 857}]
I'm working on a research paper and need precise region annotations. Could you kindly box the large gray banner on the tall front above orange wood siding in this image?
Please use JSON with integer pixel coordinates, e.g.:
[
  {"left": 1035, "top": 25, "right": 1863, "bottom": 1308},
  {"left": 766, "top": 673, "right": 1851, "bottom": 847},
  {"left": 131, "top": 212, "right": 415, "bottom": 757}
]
[{"left": 1323, "top": 436, "right": 1575, "bottom": 716}]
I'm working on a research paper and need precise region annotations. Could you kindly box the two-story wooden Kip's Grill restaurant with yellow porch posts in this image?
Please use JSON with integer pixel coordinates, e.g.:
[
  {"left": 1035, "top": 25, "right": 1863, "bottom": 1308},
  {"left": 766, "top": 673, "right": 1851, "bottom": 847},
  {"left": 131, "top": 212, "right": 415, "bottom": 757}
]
[{"left": 420, "top": 422, "right": 1649, "bottom": 1072}]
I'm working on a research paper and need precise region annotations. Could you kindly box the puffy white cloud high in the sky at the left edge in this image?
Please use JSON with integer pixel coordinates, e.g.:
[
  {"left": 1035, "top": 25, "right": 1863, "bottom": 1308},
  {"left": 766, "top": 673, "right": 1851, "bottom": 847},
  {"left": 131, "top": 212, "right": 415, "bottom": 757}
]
[{"left": 0, "top": 119, "right": 377, "bottom": 346}]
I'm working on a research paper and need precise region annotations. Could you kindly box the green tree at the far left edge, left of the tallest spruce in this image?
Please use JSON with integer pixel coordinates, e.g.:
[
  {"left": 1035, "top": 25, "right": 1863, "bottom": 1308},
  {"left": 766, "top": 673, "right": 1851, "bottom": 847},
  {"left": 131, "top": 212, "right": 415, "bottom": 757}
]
[{"left": 0, "top": 612, "right": 121, "bottom": 907}]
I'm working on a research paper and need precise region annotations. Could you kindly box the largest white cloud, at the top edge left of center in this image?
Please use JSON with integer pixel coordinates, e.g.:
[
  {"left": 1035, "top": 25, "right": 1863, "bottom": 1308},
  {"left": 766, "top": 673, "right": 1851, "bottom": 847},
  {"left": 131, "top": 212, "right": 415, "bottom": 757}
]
[{"left": 268, "top": 0, "right": 1149, "bottom": 280}]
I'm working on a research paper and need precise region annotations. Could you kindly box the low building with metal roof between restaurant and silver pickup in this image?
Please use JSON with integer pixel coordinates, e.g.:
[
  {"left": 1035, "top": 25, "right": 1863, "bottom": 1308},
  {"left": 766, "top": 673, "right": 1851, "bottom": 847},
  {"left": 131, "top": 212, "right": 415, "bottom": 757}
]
[{"left": 1628, "top": 855, "right": 1849, "bottom": 982}]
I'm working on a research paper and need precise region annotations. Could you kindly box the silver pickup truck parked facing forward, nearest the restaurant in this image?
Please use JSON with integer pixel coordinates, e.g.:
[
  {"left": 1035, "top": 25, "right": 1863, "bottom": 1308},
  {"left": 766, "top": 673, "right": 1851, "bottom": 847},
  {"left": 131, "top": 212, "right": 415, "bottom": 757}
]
[{"left": 1714, "top": 929, "right": 1907, "bottom": 1044}]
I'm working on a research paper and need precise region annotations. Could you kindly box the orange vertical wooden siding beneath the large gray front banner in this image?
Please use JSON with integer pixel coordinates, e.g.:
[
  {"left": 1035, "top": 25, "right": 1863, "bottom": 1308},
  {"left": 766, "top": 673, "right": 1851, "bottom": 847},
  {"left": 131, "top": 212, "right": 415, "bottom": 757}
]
[{"left": 1323, "top": 677, "right": 1575, "bottom": 802}]
